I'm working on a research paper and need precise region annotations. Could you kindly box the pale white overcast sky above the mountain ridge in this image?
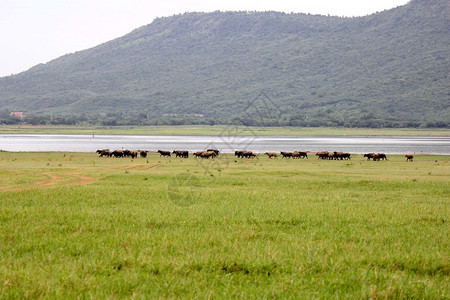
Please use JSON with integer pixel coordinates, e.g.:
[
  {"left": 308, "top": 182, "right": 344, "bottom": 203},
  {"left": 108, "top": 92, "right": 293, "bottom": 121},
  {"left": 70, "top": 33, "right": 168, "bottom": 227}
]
[{"left": 0, "top": 0, "right": 409, "bottom": 77}]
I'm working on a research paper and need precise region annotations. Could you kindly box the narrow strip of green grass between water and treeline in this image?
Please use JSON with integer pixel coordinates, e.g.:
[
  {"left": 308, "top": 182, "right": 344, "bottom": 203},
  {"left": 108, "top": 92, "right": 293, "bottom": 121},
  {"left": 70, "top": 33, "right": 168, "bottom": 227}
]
[{"left": 0, "top": 125, "right": 450, "bottom": 136}]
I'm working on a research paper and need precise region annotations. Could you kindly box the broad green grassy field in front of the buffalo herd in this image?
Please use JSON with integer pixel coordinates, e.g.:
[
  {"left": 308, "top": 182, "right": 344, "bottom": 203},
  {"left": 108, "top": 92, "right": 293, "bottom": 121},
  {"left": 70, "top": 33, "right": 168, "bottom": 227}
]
[{"left": 0, "top": 152, "right": 450, "bottom": 299}]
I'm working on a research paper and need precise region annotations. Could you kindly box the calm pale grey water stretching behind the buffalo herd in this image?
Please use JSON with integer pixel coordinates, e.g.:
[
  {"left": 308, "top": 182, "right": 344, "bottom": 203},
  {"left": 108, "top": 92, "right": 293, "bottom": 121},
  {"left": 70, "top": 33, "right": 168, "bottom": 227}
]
[{"left": 0, "top": 134, "right": 450, "bottom": 155}]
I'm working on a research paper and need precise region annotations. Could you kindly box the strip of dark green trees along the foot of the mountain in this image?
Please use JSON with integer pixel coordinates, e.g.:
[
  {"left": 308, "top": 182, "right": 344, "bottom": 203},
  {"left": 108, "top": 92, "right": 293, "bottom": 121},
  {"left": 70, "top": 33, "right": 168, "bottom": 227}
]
[{"left": 0, "top": 110, "right": 450, "bottom": 128}]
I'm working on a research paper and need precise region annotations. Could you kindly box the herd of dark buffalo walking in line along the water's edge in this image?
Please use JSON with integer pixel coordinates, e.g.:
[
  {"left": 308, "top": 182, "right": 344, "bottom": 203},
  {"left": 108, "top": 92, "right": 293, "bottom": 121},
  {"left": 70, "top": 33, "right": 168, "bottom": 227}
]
[{"left": 96, "top": 149, "right": 414, "bottom": 162}]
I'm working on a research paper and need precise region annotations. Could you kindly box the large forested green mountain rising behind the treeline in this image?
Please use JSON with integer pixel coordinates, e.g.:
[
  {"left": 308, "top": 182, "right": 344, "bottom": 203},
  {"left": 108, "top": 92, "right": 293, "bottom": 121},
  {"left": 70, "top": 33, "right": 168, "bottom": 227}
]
[{"left": 0, "top": 0, "right": 450, "bottom": 127}]
